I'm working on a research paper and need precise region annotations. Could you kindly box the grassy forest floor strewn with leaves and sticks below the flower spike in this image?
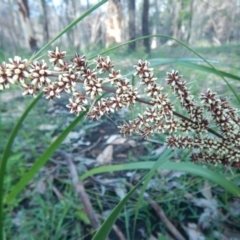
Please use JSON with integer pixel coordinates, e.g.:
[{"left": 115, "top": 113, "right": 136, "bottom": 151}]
[{"left": 0, "top": 44, "right": 240, "bottom": 240}]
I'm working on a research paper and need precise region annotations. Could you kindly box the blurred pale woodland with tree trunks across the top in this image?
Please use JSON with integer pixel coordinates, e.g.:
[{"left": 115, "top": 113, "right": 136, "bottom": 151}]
[{"left": 0, "top": 0, "right": 240, "bottom": 55}]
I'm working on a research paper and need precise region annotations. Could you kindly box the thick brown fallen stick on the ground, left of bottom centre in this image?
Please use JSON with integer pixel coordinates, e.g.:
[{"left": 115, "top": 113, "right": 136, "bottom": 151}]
[{"left": 58, "top": 150, "right": 99, "bottom": 230}]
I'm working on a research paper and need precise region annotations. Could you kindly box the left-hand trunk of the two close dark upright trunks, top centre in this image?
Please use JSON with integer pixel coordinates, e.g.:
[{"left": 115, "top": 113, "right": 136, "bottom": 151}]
[{"left": 128, "top": 0, "right": 136, "bottom": 51}]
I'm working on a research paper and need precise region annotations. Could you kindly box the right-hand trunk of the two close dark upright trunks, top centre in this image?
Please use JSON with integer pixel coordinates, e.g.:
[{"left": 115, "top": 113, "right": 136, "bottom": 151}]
[{"left": 142, "top": 0, "right": 150, "bottom": 53}]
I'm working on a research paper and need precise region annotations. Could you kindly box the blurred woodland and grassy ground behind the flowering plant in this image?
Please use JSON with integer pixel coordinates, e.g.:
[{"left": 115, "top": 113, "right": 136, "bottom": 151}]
[{"left": 0, "top": 0, "right": 240, "bottom": 240}]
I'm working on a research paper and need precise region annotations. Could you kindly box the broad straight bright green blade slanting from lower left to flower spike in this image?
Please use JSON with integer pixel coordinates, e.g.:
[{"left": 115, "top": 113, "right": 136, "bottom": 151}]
[{"left": 4, "top": 112, "right": 86, "bottom": 203}]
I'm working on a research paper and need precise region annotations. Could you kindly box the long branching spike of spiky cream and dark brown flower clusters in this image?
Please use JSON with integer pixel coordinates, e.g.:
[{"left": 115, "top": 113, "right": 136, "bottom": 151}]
[{"left": 0, "top": 48, "right": 240, "bottom": 167}]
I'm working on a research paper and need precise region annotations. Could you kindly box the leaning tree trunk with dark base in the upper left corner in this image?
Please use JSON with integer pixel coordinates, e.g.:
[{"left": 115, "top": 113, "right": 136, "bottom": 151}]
[{"left": 18, "top": 0, "right": 37, "bottom": 52}]
